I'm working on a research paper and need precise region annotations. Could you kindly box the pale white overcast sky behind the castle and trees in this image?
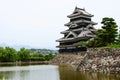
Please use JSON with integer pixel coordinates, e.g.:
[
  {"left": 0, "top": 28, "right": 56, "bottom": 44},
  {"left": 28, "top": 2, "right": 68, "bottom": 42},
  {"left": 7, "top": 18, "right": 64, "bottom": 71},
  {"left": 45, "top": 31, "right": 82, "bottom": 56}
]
[{"left": 0, "top": 0, "right": 120, "bottom": 49}]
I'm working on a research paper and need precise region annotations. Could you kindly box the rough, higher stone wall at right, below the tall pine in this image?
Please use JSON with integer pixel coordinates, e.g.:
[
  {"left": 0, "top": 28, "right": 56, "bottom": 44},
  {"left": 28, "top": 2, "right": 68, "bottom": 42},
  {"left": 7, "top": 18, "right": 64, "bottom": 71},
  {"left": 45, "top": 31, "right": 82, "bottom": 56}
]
[{"left": 77, "top": 48, "right": 120, "bottom": 72}]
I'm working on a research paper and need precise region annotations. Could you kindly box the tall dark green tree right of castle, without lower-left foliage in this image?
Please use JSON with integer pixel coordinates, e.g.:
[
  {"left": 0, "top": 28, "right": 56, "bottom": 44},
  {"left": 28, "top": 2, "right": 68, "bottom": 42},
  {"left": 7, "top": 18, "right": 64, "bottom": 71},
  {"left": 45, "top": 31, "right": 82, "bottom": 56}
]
[{"left": 101, "top": 17, "right": 118, "bottom": 46}]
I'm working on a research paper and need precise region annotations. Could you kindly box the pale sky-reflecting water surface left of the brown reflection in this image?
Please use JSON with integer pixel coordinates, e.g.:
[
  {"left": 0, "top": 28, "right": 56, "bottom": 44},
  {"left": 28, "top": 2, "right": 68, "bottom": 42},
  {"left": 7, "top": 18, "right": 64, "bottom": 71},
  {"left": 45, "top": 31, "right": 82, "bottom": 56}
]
[{"left": 0, "top": 65, "right": 59, "bottom": 80}]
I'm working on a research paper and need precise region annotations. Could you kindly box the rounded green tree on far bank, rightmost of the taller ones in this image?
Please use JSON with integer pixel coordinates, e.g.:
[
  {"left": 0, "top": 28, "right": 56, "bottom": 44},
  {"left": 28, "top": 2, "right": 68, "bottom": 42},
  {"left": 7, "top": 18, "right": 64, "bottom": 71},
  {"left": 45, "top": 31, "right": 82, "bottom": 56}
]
[{"left": 18, "top": 48, "right": 30, "bottom": 61}]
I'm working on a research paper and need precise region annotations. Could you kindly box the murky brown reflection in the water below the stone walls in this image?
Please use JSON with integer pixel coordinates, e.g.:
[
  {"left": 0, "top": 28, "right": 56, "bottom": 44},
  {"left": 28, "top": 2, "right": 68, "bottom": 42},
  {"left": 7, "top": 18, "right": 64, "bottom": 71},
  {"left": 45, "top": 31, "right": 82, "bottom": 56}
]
[{"left": 59, "top": 66, "right": 120, "bottom": 80}]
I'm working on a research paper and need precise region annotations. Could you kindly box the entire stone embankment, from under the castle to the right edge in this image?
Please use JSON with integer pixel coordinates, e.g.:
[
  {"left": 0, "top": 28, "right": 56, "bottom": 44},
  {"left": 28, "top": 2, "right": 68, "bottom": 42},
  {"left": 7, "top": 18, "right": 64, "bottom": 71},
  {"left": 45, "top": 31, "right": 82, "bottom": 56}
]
[{"left": 51, "top": 48, "right": 120, "bottom": 72}]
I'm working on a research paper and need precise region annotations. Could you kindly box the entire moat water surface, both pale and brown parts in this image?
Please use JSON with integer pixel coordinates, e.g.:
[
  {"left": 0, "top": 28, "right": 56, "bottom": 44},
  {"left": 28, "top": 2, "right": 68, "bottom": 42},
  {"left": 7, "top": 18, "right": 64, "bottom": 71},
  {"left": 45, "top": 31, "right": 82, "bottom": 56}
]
[{"left": 0, "top": 65, "right": 120, "bottom": 80}]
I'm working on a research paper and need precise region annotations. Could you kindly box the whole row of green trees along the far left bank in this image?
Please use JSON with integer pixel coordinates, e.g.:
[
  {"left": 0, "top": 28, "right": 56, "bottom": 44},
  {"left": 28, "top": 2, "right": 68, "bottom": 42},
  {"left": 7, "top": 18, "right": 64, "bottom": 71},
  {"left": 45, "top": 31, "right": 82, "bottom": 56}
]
[{"left": 0, "top": 47, "right": 55, "bottom": 62}]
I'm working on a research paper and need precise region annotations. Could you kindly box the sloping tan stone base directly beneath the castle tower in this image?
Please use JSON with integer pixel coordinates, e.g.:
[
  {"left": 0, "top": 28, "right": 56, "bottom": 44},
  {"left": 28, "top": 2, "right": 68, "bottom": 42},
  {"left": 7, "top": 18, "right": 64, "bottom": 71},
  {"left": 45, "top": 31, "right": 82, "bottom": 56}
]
[{"left": 50, "top": 53, "right": 85, "bottom": 70}]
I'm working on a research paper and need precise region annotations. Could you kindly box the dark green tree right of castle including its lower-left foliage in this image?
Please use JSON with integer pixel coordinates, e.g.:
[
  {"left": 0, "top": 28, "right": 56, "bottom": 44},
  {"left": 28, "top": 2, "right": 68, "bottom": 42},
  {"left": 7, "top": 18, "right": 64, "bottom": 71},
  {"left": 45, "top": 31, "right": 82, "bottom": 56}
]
[{"left": 95, "top": 17, "right": 118, "bottom": 47}]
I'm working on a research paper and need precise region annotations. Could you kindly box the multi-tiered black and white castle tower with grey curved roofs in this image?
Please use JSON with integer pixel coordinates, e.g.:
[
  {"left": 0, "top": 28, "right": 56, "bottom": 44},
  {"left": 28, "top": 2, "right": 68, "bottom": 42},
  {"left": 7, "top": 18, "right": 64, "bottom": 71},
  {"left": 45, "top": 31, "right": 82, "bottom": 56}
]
[{"left": 56, "top": 7, "right": 97, "bottom": 53}]
